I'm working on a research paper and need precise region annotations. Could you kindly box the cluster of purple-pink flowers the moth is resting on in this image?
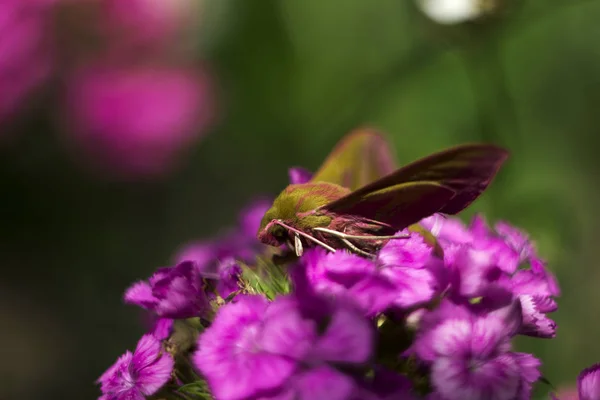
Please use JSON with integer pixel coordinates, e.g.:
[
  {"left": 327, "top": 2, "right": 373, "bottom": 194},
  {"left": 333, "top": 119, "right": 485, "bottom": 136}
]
[{"left": 100, "top": 169, "right": 600, "bottom": 400}]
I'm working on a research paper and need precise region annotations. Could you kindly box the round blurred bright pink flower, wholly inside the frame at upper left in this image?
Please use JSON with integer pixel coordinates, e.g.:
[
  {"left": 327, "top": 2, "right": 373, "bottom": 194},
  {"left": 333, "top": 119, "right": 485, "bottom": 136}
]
[{"left": 66, "top": 66, "right": 212, "bottom": 177}]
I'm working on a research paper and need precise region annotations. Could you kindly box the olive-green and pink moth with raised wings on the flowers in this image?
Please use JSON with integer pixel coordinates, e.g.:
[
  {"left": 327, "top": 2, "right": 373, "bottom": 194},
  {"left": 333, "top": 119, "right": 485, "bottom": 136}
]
[{"left": 257, "top": 130, "right": 509, "bottom": 257}]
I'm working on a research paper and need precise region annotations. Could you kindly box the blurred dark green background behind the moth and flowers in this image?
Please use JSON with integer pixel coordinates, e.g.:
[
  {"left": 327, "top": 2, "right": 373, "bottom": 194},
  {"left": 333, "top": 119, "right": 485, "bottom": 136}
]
[{"left": 0, "top": 0, "right": 600, "bottom": 400}]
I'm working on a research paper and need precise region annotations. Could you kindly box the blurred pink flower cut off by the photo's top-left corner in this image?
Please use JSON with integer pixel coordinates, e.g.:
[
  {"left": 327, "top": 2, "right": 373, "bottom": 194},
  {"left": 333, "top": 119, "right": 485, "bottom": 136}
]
[{"left": 0, "top": 0, "right": 52, "bottom": 122}]
